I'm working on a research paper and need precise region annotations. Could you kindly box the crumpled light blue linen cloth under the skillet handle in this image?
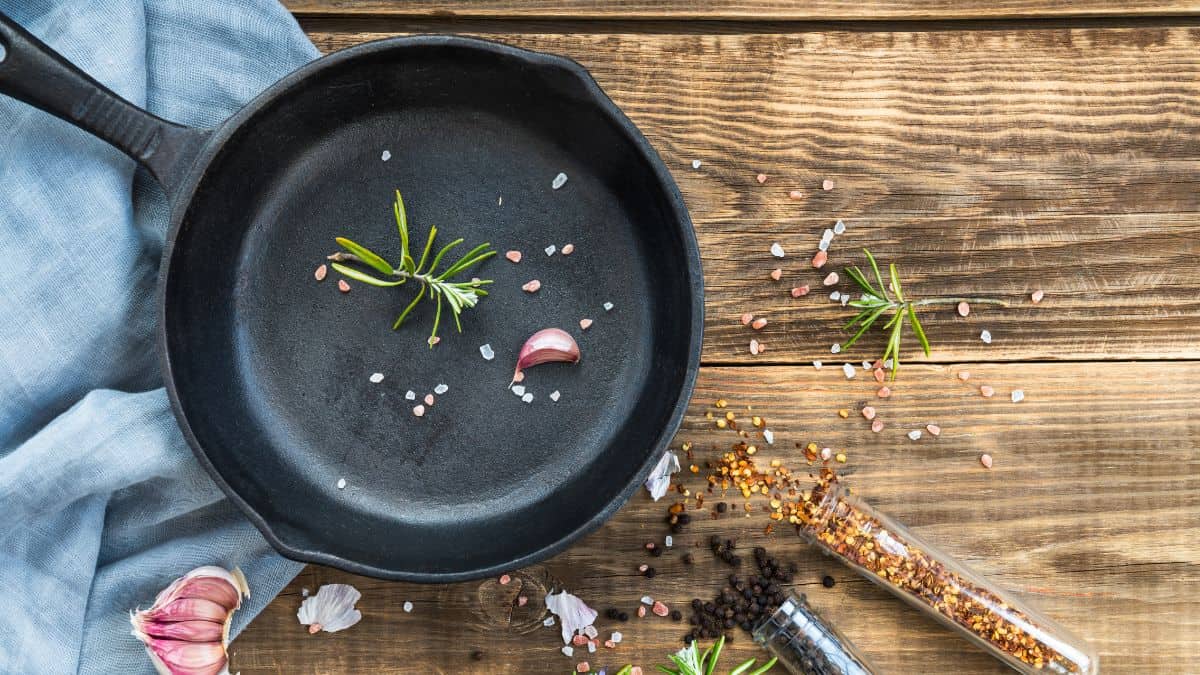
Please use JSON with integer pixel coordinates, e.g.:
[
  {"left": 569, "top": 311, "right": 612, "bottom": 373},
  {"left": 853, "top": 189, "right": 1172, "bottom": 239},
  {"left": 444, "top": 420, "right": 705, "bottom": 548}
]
[{"left": 0, "top": 0, "right": 317, "bottom": 675}]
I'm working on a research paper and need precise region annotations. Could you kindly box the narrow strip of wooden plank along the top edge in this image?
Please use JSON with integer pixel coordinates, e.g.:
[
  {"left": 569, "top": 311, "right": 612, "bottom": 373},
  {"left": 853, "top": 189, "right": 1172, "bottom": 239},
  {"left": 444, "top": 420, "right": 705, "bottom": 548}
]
[{"left": 283, "top": 0, "right": 1200, "bottom": 22}]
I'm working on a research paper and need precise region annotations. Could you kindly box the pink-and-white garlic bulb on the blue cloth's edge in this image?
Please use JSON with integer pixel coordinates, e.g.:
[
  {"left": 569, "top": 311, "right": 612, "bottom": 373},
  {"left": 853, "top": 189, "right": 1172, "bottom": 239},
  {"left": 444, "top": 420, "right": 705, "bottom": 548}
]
[{"left": 130, "top": 566, "right": 250, "bottom": 675}]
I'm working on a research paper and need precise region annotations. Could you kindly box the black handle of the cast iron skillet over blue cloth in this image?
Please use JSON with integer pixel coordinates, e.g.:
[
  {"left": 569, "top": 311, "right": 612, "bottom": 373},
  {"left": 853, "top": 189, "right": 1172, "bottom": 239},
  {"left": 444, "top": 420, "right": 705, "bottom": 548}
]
[{"left": 0, "top": 12, "right": 209, "bottom": 201}]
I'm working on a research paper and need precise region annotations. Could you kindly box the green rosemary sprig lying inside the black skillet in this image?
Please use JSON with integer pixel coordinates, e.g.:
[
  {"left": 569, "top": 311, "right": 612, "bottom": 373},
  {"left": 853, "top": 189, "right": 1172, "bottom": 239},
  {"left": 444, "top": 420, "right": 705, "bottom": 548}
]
[{"left": 329, "top": 190, "right": 496, "bottom": 348}]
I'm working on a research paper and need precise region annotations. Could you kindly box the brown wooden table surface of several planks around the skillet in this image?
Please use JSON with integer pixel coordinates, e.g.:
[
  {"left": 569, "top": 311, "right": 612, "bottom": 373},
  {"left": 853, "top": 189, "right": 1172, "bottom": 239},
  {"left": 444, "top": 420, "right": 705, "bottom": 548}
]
[{"left": 230, "top": 0, "right": 1200, "bottom": 675}]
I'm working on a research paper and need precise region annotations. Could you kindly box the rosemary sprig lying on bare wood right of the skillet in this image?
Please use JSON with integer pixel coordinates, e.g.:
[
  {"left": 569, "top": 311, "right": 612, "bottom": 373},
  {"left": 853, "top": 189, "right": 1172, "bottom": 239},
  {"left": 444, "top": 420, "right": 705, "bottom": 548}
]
[{"left": 841, "top": 249, "right": 1008, "bottom": 380}]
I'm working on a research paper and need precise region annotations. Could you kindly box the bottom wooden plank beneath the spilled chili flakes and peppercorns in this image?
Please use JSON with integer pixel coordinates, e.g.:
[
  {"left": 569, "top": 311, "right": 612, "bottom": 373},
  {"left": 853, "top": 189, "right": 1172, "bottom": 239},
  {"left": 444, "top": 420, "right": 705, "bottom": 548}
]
[{"left": 230, "top": 363, "right": 1200, "bottom": 675}]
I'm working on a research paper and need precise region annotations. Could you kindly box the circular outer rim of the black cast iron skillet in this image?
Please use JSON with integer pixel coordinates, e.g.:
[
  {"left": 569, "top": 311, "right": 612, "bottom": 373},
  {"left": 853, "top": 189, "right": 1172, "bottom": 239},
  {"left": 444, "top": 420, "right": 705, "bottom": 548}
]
[{"left": 156, "top": 35, "right": 704, "bottom": 584}]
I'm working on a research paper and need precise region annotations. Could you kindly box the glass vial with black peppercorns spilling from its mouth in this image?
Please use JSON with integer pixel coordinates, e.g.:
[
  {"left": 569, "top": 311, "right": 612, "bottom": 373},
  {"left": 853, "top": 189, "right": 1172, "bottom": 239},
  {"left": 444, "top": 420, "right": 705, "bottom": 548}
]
[{"left": 754, "top": 593, "right": 877, "bottom": 675}]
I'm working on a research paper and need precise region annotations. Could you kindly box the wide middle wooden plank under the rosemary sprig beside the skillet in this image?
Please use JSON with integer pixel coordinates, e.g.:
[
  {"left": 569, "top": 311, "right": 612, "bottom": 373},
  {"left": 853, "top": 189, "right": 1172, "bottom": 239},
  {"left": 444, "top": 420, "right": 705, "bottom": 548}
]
[{"left": 300, "top": 22, "right": 1200, "bottom": 364}]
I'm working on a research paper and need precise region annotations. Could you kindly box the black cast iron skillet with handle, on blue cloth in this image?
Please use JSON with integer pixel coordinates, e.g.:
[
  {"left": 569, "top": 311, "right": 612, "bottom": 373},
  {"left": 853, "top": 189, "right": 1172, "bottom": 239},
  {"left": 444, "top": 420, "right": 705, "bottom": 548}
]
[{"left": 0, "top": 17, "right": 703, "bottom": 581}]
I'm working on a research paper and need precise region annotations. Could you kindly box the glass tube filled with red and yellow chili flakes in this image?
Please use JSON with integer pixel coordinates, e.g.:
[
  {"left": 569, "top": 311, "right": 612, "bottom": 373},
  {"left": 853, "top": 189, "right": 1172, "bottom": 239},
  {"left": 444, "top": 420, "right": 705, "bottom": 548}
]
[{"left": 798, "top": 480, "right": 1099, "bottom": 675}]
